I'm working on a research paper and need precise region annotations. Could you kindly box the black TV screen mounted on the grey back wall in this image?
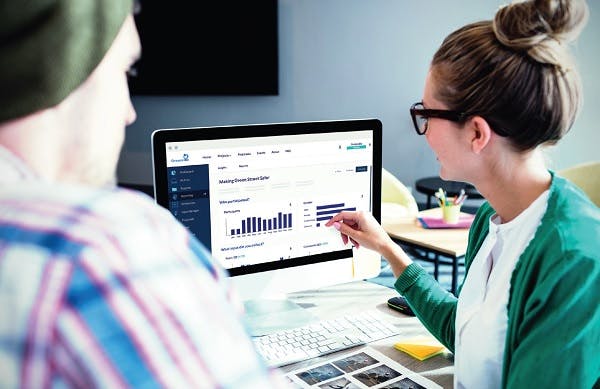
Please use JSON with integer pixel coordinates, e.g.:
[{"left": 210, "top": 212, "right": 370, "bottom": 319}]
[{"left": 130, "top": 0, "right": 279, "bottom": 95}]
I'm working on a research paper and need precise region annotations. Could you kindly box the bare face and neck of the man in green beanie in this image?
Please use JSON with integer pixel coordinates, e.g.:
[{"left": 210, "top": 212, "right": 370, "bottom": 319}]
[{"left": 63, "top": 15, "right": 141, "bottom": 186}]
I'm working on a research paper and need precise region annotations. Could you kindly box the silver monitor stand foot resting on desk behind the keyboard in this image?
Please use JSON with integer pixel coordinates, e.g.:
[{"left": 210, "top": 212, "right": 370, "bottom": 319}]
[{"left": 244, "top": 298, "right": 317, "bottom": 336}]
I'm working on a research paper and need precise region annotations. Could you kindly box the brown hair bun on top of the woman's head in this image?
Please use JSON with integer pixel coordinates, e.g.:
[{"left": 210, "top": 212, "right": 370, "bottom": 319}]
[{"left": 493, "top": 0, "right": 588, "bottom": 69}]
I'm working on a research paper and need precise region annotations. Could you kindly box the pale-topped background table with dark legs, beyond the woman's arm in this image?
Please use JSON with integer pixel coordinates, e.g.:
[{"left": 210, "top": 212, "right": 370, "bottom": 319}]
[{"left": 381, "top": 203, "right": 469, "bottom": 294}]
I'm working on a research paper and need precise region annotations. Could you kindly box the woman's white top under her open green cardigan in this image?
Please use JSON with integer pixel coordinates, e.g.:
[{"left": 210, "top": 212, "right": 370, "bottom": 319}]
[{"left": 454, "top": 190, "right": 550, "bottom": 388}]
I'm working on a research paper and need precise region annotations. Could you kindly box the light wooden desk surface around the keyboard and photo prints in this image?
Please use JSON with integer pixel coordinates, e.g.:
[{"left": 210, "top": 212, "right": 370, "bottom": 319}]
[{"left": 281, "top": 281, "right": 454, "bottom": 388}]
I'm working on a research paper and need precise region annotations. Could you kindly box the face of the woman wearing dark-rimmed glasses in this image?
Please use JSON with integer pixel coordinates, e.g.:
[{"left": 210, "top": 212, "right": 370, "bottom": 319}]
[{"left": 423, "top": 71, "right": 470, "bottom": 181}]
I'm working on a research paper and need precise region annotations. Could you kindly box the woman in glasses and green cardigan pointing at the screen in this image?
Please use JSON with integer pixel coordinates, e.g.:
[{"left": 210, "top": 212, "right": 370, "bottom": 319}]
[{"left": 327, "top": 0, "right": 600, "bottom": 388}]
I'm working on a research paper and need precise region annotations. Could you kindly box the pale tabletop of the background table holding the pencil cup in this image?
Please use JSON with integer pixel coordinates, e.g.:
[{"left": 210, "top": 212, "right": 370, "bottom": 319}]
[{"left": 381, "top": 203, "right": 469, "bottom": 257}]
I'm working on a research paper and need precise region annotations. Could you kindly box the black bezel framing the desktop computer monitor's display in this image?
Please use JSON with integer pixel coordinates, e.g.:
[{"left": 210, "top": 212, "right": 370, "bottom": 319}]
[{"left": 152, "top": 119, "right": 382, "bottom": 276}]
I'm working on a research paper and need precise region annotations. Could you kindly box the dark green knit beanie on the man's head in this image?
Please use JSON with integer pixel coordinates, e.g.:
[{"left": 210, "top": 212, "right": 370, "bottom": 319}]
[{"left": 0, "top": 0, "right": 132, "bottom": 123}]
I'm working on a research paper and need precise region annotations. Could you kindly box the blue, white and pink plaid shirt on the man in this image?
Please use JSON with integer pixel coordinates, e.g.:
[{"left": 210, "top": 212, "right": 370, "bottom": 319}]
[{"left": 0, "top": 147, "right": 281, "bottom": 388}]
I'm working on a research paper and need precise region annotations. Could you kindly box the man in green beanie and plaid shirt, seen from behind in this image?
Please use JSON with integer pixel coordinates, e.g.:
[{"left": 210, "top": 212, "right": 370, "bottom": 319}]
[{"left": 0, "top": 0, "right": 281, "bottom": 388}]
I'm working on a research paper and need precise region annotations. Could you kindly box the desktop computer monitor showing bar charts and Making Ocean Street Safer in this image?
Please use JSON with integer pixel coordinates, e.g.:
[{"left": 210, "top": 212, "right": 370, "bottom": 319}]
[{"left": 152, "top": 119, "right": 382, "bottom": 299}]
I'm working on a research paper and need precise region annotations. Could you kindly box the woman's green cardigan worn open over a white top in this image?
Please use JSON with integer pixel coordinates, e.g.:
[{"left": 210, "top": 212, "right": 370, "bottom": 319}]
[{"left": 395, "top": 174, "right": 600, "bottom": 388}]
